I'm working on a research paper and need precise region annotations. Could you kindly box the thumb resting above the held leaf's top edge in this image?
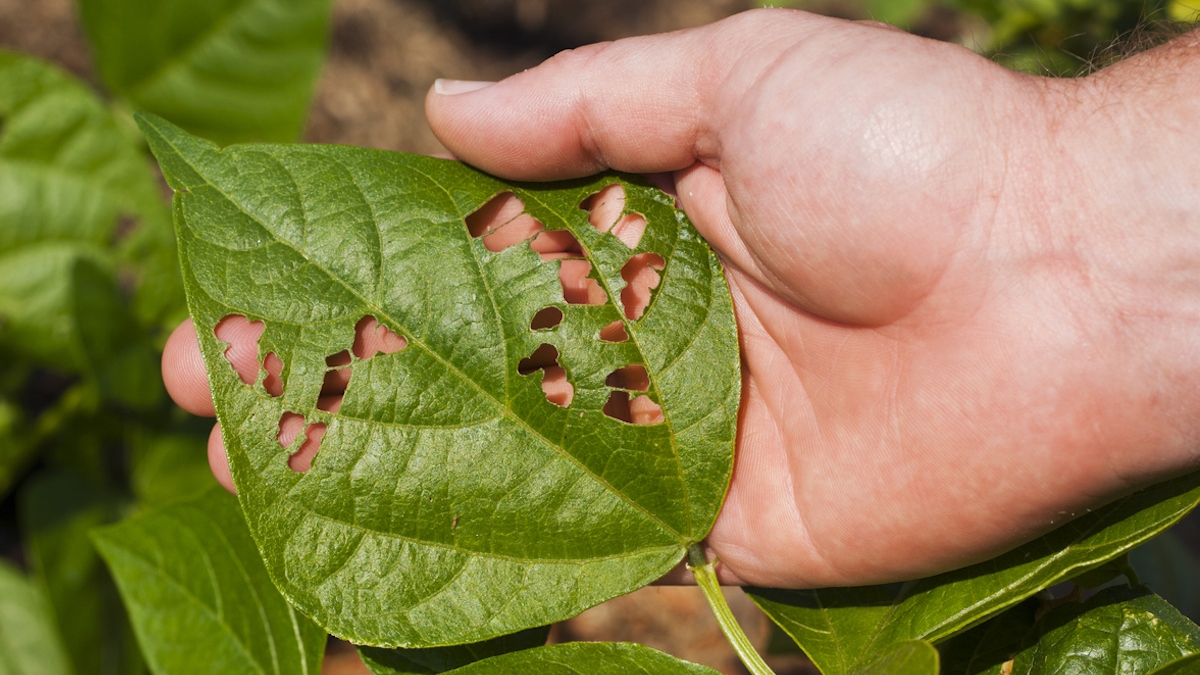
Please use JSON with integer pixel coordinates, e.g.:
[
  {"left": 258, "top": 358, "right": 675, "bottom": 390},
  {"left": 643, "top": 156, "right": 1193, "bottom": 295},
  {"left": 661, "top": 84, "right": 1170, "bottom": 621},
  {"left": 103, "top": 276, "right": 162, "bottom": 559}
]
[{"left": 425, "top": 10, "right": 816, "bottom": 180}]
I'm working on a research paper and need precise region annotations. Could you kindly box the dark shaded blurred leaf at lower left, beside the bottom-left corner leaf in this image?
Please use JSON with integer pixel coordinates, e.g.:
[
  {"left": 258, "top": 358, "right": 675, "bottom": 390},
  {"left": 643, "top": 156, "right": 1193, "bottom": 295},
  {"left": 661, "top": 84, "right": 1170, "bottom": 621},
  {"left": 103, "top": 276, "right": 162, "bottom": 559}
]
[{"left": 20, "top": 473, "right": 142, "bottom": 675}]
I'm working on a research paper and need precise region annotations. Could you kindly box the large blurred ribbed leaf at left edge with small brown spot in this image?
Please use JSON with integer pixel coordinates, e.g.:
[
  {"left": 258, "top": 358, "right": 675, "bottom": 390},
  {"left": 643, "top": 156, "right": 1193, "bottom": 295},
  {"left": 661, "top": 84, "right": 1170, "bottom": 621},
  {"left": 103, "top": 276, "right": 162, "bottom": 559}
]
[{"left": 0, "top": 50, "right": 181, "bottom": 329}]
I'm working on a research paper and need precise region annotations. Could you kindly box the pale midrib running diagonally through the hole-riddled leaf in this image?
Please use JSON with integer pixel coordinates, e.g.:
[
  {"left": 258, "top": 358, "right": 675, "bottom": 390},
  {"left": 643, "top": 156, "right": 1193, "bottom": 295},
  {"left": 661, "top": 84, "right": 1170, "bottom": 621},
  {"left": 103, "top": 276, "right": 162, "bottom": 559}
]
[{"left": 172, "top": 133, "right": 691, "bottom": 546}]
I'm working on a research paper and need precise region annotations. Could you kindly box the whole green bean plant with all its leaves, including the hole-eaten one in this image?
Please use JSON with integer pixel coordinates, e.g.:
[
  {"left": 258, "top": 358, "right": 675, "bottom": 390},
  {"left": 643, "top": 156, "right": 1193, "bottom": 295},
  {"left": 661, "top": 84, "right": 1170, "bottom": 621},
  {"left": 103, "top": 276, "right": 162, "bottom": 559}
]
[{"left": 0, "top": 0, "right": 1200, "bottom": 675}]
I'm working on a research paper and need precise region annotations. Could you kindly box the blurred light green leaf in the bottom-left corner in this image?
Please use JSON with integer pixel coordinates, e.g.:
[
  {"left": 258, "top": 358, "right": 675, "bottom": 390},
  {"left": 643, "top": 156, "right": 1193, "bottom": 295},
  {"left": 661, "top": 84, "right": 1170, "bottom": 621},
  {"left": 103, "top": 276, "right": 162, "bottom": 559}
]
[{"left": 0, "top": 560, "right": 71, "bottom": 675}]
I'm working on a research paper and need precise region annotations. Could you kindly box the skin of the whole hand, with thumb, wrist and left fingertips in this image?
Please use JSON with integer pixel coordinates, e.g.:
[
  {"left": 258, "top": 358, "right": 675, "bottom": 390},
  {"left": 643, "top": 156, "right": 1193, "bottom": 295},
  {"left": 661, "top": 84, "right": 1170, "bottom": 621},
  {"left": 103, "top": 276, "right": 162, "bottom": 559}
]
[{"left": 163, "top": 10, "right": 1200, "bottom": 587}]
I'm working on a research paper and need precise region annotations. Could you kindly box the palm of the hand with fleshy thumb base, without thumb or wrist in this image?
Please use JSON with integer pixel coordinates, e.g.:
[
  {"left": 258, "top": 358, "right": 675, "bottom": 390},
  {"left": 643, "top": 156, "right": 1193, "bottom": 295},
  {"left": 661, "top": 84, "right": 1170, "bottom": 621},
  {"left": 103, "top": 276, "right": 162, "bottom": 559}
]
[{"left": 657, "top": 25, "right": 1190, "bottom": 586}]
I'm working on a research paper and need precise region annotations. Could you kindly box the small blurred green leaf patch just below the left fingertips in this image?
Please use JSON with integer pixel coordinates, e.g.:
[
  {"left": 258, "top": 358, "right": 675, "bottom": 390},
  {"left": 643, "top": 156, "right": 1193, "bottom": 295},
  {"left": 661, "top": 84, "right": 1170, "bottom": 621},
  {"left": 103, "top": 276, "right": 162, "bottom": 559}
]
[{"left": 132, "top": 435, "right": 215, "bottom": 508}]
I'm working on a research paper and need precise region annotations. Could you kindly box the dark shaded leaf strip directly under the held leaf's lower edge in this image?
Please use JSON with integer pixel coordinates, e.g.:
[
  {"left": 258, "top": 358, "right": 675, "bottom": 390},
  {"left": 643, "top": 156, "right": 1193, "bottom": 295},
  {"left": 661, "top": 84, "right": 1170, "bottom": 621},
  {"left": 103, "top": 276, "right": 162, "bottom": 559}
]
[{"left": 359, "top": 626, "right": 550, "bottom": 675}]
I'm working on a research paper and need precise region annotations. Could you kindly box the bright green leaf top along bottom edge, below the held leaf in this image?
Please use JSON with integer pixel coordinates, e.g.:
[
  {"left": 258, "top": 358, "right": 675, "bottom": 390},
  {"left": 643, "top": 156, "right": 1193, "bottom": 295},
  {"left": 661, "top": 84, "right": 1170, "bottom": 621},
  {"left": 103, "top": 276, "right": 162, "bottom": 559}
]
[{"left": 371, "top": 643, "right": 716, "bottom": 675}]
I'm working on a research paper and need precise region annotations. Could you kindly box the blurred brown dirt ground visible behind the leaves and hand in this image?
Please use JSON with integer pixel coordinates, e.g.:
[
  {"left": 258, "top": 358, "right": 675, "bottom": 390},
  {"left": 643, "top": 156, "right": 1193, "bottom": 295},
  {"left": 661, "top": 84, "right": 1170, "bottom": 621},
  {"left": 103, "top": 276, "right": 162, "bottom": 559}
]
[{"left": 0, "top": 0, "right": 816, "bottom": 675}]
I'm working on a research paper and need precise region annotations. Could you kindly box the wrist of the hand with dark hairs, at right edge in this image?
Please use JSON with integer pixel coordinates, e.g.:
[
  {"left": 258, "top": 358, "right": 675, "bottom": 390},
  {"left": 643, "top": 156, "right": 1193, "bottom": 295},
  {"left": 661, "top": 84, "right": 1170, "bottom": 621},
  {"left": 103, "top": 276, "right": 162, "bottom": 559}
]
[{"left": 1037, "top": 40, "right": 1200, "bottom": 485}]
